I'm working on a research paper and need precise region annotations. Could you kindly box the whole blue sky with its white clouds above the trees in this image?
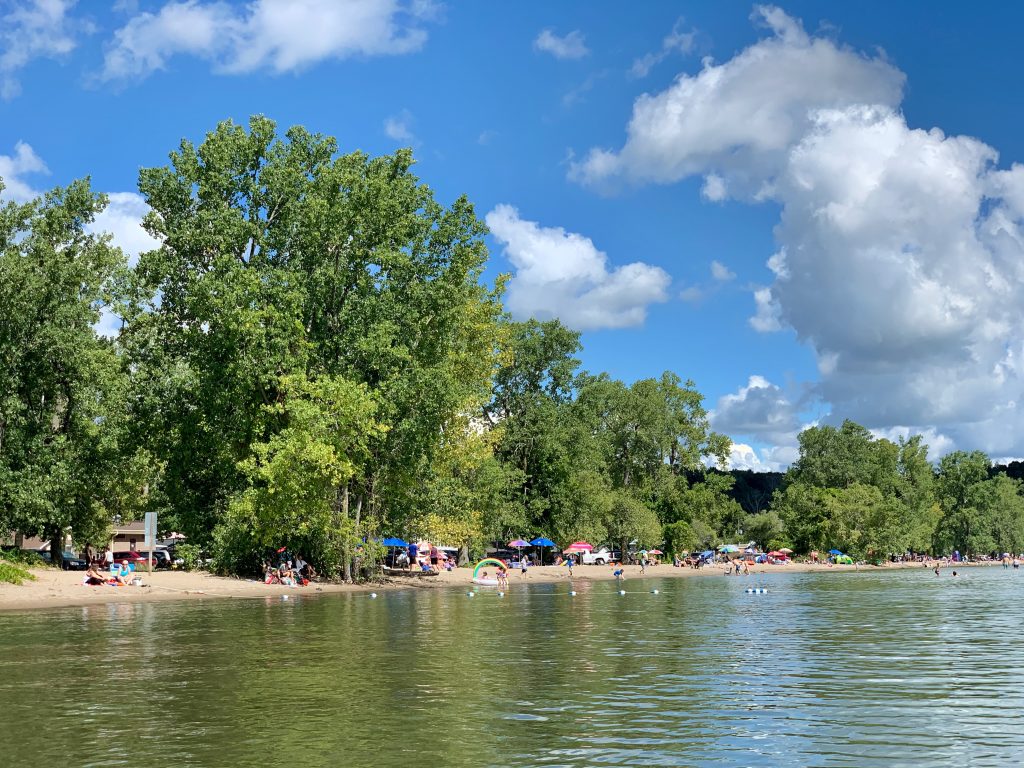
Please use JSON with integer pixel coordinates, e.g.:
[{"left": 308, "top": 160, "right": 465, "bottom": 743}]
[{"left": 6, "top": 0, "right": 1024, "bottom": 468}]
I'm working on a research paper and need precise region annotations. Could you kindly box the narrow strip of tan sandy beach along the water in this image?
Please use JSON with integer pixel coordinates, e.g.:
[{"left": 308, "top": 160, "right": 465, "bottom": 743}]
[{"left": 0, "top": 561, "right": 1000, "bottom": 612}]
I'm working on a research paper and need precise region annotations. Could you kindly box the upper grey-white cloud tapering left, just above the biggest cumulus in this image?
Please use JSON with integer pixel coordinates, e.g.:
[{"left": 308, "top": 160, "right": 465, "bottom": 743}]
[{"left": 570, "top": 7, "right": 904, "bottom": 190}]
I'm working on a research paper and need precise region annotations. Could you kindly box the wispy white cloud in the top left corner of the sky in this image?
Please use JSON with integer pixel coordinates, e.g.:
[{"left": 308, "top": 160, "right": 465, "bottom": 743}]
[{"left": 0, "top": 0, "right": 90, "bottom": 99}]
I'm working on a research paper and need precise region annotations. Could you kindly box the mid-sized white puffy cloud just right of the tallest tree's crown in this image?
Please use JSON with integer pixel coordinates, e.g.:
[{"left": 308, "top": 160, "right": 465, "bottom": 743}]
[{"left": 485, "top": 205, "right": 671, "bottom": 331}]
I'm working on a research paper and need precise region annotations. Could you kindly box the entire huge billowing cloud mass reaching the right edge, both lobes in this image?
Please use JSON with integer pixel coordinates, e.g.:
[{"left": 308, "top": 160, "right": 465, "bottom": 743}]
[{"left": 571, "top": 8, "right": 1024, "bottom": 456}]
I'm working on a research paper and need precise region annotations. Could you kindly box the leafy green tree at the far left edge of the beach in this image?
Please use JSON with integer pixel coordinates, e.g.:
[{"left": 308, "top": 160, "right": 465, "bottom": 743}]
[{"left": 0, "top": 180, "right": 134, "bottom": 552}]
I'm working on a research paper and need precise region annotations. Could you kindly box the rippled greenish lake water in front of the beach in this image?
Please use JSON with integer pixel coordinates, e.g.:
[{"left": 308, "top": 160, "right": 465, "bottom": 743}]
[{"left": 0, "top": 568, "right": 1024, "bottom": 768}]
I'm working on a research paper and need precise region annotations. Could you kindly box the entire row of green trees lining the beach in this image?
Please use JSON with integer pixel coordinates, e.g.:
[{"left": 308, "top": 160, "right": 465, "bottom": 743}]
[{"left": 0, "top": 118, "right": 1024, "bottom": 578}]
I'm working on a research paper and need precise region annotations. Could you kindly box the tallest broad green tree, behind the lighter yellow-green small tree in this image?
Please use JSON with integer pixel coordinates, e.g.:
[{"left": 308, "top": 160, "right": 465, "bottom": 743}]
[{"left": 130, "top": 117, "right": 501, "bottom": 573}]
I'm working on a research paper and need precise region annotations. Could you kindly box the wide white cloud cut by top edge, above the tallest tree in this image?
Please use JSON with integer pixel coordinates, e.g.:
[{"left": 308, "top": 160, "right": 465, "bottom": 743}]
[{"left": 100, "top": 0, "right": 433, "bottom": 80}]
